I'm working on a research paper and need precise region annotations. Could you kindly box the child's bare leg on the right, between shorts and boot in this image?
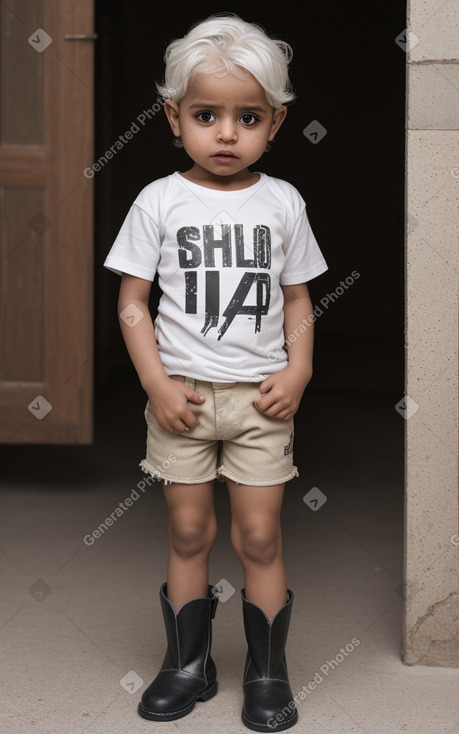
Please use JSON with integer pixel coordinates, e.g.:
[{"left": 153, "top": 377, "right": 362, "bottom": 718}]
[{"left": 226, "top": 479, "right": 287, "bottom": 620}]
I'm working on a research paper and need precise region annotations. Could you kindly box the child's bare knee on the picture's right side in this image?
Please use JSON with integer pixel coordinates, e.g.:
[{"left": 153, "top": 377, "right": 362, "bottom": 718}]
[{"left": 231, "top": 524, "right": 282, "bottom": 565}]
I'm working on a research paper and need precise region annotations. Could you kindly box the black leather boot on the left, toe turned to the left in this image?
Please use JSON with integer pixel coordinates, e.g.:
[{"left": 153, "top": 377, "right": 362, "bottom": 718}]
[{"left": 137, "top": 583, "right": 218, "bottom": 721}]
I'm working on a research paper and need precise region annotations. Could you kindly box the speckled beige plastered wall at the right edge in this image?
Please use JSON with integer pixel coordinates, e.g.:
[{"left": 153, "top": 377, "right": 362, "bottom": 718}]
[{"left": 402, "top": 0, "right": 459, "bottom": 667}]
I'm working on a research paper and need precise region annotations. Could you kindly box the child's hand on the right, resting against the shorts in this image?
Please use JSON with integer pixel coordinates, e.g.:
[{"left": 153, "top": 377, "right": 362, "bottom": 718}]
[{"left": 253, "top": 366, "right": 312, "bottom": 421}]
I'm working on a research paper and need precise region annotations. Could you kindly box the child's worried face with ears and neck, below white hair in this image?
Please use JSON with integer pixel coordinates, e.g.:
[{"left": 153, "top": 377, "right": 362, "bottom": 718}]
[{"left": 164, "top": 72, "right": 287, "bottom": 183}]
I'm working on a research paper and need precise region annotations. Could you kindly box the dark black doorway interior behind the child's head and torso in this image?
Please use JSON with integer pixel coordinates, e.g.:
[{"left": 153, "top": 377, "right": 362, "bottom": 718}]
[{"left": 94, "top": 0, "right": 405, "bottom": 428}]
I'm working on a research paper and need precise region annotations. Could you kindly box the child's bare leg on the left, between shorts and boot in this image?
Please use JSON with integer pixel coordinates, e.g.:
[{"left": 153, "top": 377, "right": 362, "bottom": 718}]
[{"left": 163, "top": 481, "right": 217, "bottom": 612}]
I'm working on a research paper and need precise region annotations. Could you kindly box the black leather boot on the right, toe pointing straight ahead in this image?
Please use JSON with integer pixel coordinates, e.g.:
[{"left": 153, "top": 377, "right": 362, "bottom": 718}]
[{"left": 241, "top": 589, "right": 298, "bottom": 732}]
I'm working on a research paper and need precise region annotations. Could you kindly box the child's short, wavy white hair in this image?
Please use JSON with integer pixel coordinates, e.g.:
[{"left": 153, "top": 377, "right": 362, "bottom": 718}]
[{"left": 156, "top": 14, "right": 295, "bottom": 108}]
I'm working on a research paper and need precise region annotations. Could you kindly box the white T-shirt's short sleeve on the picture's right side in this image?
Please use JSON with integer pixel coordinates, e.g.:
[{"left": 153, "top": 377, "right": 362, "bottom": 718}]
[{"left": 280, "top": 207, "right": 328, "bottom": 285}]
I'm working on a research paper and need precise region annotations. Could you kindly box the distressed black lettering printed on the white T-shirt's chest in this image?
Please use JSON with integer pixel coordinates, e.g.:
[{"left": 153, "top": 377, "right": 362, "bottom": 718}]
[{"left": 177, "top": 224, "right": 271, "bottom": 339}]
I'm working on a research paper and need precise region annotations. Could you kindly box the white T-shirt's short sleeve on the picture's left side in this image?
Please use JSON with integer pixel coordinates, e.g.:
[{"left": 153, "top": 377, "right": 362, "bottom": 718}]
[{"left": 104, "top": 202, "right": 160, "bottom": 281}]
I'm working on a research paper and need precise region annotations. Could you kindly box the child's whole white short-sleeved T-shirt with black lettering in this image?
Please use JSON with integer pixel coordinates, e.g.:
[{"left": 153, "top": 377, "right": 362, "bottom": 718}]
[{"left": 104, "top": 171, "right": 327, "bottom": 382}]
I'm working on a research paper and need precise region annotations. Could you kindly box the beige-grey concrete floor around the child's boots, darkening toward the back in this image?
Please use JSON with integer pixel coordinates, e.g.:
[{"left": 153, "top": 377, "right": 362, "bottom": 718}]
[{"left": 0, "top": 385, "right": 459, "bottom": 734}]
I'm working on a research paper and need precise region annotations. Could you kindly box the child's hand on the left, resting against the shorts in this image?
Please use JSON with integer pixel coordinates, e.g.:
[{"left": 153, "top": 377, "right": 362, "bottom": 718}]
[{"left": 147, "top": 377, "right": 205, "bottom": 433}]
